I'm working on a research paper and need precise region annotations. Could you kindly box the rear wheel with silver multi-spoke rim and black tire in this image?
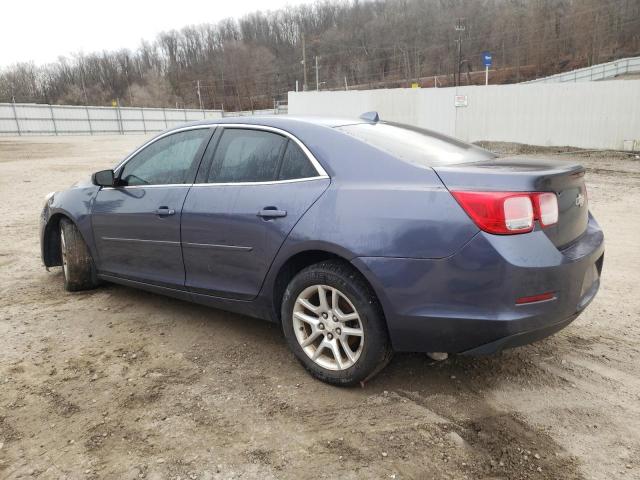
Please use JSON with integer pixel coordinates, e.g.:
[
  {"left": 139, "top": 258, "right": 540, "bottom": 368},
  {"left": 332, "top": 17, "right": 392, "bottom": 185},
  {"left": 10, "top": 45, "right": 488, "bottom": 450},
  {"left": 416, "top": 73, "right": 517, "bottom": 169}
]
[{"left": 281, "top": 260, "right": 392, "bottom": 386}]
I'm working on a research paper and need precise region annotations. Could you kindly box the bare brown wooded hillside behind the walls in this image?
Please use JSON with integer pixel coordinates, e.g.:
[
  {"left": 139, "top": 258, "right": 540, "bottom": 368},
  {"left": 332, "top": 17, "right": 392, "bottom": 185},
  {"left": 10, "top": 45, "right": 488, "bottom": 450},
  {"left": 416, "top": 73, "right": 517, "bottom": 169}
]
[{"left": 0, "top": 0, "right": 640, "bottom": 110}]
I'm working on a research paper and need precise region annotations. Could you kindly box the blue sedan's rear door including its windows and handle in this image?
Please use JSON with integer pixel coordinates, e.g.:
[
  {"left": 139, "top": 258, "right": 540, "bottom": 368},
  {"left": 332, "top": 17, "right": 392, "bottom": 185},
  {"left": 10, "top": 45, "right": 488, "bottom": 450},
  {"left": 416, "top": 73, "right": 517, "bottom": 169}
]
[{"left": 182, "top": 126, "right": 329, "bottom": 300}]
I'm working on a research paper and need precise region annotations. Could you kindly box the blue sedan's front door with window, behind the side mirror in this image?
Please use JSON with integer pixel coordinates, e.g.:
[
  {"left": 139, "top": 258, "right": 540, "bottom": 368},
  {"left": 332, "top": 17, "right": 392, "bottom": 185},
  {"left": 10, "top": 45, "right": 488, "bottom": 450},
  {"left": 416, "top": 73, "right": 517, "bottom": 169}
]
[{"left": 92, "top": 127, "right": 212, "bottom": 289}]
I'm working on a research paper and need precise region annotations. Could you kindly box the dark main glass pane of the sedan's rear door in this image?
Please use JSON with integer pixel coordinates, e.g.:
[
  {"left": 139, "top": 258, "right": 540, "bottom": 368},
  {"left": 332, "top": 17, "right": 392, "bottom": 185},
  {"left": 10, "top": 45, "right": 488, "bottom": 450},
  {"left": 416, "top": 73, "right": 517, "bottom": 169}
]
[{"left": 207, "top": 128, "right": 287, "bottom": 183}]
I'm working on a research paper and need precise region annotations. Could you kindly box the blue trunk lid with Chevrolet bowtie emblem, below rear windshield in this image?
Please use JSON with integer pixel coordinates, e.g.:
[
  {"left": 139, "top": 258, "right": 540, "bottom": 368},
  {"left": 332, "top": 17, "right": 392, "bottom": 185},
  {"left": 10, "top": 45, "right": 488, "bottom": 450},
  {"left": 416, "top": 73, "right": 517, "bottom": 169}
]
[{"left": 433, "top": 157, "right": 589, "bottom": 248}]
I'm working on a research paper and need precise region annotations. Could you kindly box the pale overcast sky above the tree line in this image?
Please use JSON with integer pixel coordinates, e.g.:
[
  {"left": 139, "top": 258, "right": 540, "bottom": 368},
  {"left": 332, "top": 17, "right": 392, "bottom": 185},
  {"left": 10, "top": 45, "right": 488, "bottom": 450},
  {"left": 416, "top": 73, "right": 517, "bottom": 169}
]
[{"left": 0, "top": 0, "right": 311, "bottom": 67}]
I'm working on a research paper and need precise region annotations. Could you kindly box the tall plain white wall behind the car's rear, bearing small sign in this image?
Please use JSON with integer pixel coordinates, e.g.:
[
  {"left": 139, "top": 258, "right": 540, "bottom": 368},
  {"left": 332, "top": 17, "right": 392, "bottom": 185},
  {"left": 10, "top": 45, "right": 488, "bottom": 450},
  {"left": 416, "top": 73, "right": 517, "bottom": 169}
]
[{"left": 289, "top": 80, "right": 640, "bottom": 150}]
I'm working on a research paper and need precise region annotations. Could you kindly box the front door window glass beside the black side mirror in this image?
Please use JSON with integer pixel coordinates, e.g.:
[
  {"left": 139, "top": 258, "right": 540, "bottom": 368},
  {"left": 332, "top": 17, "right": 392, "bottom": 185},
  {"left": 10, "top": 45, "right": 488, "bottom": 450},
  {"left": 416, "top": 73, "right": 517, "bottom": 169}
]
[{"left": 120, "top": 128, "right": 211, "bottom": 186}]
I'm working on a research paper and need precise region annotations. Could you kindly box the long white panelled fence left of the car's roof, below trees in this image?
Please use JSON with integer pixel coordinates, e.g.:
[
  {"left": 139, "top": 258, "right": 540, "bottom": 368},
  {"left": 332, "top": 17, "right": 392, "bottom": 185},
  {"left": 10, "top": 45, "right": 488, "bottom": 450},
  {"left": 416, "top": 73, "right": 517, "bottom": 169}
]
[{"left": 0, "top": 103, "right": 223, "bottom": 135}]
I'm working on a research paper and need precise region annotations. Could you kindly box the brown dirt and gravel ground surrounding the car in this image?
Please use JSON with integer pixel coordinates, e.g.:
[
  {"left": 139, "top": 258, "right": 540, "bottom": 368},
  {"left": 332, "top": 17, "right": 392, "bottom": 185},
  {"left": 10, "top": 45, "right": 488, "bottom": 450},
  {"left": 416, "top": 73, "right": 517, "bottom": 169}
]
[{"left": 0, "top": 136, "right": 640, "bottom": 480}]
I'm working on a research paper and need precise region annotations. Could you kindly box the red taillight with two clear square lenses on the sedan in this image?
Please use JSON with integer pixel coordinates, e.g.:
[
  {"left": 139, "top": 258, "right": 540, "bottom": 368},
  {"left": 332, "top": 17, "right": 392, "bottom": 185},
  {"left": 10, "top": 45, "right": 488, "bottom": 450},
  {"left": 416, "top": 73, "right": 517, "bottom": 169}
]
[{"left": 451, "top": 191, "right": 558, "bottom": 235}]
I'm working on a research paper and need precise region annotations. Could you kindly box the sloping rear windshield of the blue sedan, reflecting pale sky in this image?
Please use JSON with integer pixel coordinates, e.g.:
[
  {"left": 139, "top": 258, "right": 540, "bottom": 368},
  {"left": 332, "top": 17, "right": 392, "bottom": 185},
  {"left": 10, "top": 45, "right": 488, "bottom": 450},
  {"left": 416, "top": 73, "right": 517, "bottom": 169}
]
[{"left": 337, "top": 122, "right": 496, "bottom": 167}]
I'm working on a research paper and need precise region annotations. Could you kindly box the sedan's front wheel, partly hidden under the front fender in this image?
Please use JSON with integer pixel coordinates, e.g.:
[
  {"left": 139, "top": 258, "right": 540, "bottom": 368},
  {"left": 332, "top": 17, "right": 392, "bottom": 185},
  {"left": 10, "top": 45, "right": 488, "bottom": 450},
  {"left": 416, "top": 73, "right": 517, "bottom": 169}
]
[{"left": 60, "top": 218, "right": 98, "bottom": 292}]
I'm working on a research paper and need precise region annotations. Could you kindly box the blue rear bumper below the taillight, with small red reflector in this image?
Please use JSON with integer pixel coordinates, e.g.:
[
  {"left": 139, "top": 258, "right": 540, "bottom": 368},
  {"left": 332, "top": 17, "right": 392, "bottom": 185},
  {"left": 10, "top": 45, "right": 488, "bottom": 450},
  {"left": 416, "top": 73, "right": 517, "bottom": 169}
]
[{"left": 353, "top": 217, "right": 604, "bottom": 355}]
